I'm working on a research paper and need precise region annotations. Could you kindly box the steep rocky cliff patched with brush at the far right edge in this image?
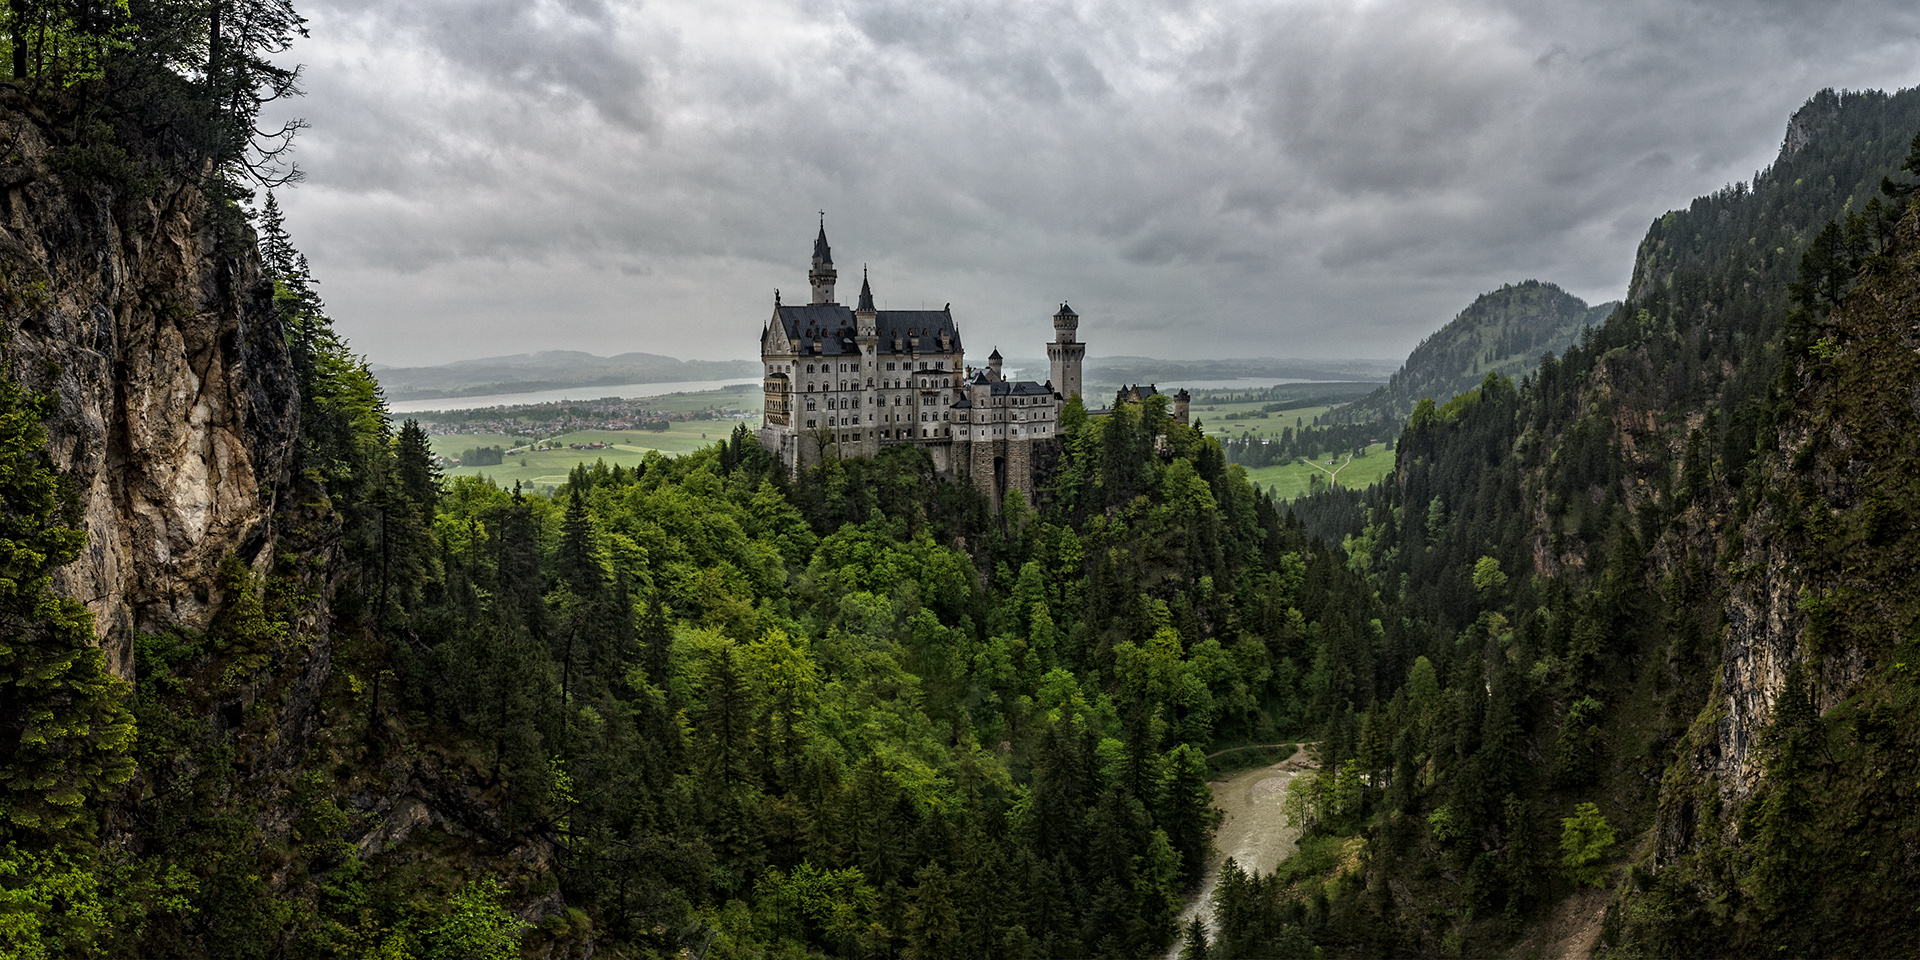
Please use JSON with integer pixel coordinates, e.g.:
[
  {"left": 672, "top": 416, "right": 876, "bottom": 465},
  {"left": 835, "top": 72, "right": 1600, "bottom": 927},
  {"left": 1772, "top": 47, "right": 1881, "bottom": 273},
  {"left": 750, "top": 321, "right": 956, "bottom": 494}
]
[{"left": 1718, "top": 207, "right": 1920, "bottom": 795}]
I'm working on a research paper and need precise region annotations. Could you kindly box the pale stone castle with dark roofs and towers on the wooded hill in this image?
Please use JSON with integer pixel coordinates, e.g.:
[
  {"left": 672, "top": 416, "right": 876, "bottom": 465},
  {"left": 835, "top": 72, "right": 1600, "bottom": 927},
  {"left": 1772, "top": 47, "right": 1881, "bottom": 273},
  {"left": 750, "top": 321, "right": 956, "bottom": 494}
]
[{"left": 760, "top": 221, "right": 1087, "bottom": 501}]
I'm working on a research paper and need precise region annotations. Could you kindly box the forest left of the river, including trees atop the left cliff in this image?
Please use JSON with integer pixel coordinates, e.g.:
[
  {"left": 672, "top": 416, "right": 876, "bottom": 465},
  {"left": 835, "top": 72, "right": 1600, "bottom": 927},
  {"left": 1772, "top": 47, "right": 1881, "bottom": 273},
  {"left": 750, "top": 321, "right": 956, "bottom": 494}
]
[{"left": 0, "top": 9, "right": 1400, "bottom": 944}]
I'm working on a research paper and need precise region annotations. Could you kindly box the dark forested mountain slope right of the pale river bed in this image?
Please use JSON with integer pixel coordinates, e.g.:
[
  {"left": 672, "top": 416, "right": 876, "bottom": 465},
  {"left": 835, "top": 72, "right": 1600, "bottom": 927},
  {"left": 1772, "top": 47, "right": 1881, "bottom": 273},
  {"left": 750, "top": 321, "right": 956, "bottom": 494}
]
[{"left": 1259, "top": 90, "right": 1920, "bottom": 956}]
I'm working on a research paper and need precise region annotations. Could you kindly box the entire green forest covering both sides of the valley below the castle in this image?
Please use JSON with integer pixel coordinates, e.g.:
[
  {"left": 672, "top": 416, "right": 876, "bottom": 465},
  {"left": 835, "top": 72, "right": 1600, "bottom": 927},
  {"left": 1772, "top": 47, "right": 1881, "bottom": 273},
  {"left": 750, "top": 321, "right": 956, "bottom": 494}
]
[{"left": 0, "top": 0, "right": 1920, "bottom": 958}]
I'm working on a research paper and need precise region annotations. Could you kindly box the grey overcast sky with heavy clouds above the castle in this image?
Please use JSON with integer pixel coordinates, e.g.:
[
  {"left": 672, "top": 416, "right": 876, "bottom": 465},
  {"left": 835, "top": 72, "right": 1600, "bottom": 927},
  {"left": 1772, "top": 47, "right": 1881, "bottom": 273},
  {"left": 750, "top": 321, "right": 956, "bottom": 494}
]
[{"left": 266, "top": 0, "right": 1920, "bottom": 365}]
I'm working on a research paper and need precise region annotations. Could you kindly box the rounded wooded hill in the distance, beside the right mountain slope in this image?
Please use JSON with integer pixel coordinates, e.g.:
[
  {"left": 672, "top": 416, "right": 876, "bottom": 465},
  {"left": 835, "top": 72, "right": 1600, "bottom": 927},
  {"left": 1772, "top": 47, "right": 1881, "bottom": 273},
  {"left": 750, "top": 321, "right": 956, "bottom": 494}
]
[{"left": 1331, "top": 280, "right": 1619, "bottom": 422}]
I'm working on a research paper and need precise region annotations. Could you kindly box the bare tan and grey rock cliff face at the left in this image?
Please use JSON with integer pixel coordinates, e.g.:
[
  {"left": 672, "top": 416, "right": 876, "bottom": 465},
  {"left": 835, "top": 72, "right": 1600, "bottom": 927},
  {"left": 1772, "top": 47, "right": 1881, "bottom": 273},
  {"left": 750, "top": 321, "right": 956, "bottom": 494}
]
[{"left": 0, "top": 104, "right": 300, "bottom": 676}]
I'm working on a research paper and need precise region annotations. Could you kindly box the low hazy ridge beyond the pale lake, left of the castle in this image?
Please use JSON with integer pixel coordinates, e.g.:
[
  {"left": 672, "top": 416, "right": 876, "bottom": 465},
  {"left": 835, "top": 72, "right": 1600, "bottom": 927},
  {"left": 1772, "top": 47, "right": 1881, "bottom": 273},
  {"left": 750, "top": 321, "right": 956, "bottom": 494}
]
[{"left": 372, "top": 349, "right": 760, "bottom": 399}]
